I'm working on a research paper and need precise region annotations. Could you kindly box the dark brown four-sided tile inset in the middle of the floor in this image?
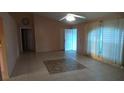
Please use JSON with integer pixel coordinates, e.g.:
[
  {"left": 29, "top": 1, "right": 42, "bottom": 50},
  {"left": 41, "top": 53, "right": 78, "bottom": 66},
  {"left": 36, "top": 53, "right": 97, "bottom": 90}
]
[{"left": 44, "top": 58, "right": 86, "bottom": 74}]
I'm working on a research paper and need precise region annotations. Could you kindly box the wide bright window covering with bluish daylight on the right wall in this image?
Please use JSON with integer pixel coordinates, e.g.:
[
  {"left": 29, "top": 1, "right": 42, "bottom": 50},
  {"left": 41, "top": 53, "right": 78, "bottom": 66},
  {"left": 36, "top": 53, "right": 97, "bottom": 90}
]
[{"left": 87, "top": 19, "right": 124, "bottom": 65}]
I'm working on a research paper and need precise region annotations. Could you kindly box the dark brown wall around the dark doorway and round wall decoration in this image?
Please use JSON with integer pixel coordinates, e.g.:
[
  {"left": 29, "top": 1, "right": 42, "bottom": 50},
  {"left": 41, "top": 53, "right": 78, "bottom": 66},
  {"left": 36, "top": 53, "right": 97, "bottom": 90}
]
[{"left": 9, "top": 12, "right": 35, "bottom": 53}]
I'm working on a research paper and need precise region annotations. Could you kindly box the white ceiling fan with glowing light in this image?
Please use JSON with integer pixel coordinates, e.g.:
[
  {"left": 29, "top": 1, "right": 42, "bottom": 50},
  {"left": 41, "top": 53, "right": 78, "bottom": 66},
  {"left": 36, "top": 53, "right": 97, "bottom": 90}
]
[{"left": 59, "top": 13, "right": 86, "bottom": 22}]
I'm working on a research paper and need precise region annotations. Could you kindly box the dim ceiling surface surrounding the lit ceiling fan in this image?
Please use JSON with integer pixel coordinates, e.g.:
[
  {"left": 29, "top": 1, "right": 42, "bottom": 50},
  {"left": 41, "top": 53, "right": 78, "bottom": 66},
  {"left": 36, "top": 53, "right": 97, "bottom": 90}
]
[{"left": 37, "top": 12, "right": 120, "bottom": 24}]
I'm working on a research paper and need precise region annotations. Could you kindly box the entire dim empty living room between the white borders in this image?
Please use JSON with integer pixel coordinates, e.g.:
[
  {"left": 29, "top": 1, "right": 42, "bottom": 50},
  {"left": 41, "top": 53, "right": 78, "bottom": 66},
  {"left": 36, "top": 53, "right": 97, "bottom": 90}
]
[{"left": 0, "top": 12, "right": 124, "bottom": 81}]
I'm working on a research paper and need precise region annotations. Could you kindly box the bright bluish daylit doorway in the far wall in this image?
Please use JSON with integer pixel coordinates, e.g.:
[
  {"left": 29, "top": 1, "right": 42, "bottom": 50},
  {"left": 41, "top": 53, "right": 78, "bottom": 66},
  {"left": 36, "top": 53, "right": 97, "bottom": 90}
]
[{"left": 65, "top": 28, "right": 77, "bottom": 52}]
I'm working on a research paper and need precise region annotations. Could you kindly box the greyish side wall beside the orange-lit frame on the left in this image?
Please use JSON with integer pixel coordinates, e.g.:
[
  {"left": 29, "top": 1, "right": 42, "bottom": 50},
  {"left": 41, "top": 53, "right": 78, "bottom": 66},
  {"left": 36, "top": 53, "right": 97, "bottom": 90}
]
[{"left": 0, "top": 13, "right": 19, "bottom": 75}]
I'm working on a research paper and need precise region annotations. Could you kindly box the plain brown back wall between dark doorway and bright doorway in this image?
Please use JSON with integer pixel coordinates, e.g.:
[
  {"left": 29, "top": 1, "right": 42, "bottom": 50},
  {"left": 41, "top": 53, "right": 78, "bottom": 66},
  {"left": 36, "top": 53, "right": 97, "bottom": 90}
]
[{"left": 34, "top": 15, "right": 64, "bottom": 52}]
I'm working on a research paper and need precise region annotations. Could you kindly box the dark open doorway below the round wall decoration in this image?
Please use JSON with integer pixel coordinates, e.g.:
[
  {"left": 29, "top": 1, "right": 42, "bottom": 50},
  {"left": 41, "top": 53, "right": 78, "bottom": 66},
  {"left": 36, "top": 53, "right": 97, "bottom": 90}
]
[{"left": 20, "top": 28, "right": 35, "bottom": 53}]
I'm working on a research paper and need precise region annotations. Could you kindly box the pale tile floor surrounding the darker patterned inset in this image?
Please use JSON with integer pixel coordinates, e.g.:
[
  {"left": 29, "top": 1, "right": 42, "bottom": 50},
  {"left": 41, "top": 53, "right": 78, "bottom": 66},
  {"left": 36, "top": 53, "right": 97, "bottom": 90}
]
[{"left": 10, "top": 52, "right": 124, "bottom": 81}]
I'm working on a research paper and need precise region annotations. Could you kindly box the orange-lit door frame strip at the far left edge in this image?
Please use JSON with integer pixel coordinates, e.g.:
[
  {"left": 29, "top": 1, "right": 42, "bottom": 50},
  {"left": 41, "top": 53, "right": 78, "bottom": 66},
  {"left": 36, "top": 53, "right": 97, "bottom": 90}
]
[{"left": 0, "top": 17, "right": 9, "bottom": 80}]
